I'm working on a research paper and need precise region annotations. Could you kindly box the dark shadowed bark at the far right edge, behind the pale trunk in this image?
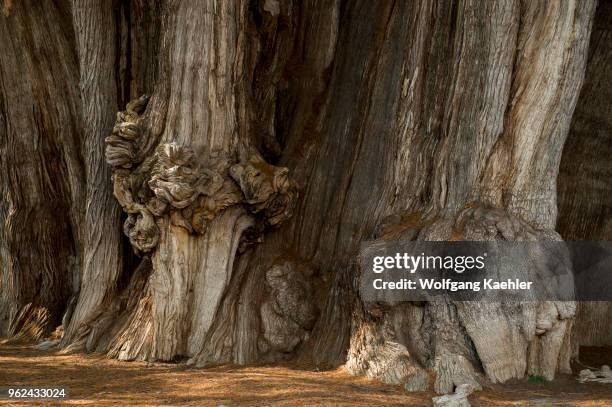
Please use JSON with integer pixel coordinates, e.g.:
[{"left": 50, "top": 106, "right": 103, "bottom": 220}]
[{"left": 557, "top": 2, "right": 612, "bottom": 346}]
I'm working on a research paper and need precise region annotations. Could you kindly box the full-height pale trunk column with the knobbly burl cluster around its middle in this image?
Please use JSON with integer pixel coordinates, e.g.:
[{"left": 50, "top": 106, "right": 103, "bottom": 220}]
[{"left": 88, "top": 2, "right": 292, "bottom": 360}]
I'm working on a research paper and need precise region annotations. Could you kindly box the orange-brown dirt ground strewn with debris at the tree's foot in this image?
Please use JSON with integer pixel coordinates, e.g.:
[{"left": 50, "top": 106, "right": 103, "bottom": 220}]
[{"left": 0, "top": 344, "right": 612, "bottom": 407}]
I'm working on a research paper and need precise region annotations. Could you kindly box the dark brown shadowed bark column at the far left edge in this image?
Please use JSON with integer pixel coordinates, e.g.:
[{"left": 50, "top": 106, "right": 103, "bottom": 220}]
[{"left": 0, "top": 1, "right": 85, "bottom": 339}]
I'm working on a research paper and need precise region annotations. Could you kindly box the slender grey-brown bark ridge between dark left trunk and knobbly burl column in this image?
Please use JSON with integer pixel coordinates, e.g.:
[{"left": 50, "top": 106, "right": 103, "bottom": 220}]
[{"left": 63, "top": 1, "right": 122, "bottom": 345}]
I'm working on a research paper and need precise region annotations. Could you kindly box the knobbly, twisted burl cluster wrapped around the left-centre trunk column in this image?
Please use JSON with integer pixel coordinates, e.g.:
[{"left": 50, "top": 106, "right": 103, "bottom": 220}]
[{"left": 105, "top": 96, "right": 297, "bottom": 253}]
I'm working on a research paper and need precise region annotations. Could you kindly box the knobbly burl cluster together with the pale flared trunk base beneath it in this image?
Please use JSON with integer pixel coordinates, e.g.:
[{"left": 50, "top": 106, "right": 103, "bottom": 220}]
[{"left": 94, "top": 97, "right": 297, "bottom": 360}]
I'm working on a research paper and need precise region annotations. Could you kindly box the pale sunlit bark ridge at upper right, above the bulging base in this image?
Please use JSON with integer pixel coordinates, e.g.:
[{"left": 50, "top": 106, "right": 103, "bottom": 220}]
[{"left": 484, "top": 2, "right": 595, "bottom": 228}]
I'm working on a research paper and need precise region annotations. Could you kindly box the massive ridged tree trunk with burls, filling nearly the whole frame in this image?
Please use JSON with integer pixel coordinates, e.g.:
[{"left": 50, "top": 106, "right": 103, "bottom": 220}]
[{"left": 0, "top": 0, "right": 595, "bottom": 392}]
